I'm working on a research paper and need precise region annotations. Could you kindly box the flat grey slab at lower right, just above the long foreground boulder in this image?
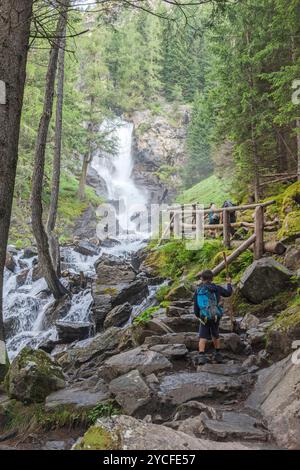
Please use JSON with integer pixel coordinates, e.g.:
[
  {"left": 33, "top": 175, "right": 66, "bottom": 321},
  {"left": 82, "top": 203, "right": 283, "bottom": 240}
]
[{"left": 202, "top": 412, "right": 268, "bottom": 441}]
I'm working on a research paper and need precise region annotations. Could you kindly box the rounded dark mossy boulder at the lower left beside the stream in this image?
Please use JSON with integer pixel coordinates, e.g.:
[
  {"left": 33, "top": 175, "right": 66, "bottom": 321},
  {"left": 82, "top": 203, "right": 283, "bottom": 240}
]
[{"left": 5, "top": 347, "right": 65, "bottom": 403}]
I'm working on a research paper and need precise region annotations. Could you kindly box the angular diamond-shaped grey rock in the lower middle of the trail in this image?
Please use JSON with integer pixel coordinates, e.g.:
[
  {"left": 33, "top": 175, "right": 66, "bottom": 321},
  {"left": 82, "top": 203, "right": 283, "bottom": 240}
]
[{"left": 109, "top": 370, "right": 152, "bottom": 415}]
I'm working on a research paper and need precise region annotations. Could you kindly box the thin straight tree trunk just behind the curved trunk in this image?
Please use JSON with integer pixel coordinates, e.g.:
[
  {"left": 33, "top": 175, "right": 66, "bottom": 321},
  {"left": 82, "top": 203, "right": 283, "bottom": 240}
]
[{"left": 47, "top": 24, "right": 67, "bottom": 276}]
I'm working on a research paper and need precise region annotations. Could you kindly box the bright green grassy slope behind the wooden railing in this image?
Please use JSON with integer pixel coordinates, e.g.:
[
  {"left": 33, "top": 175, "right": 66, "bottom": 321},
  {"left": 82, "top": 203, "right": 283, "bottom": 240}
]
[{"left": 177, "top": 175, "right": 231, "bottom": 207}]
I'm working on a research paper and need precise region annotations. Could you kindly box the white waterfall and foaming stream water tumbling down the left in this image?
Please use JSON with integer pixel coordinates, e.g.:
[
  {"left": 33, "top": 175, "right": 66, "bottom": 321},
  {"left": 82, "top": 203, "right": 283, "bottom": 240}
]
[{"left": 4, "top": 121, "right": 157, "bottom": 359}]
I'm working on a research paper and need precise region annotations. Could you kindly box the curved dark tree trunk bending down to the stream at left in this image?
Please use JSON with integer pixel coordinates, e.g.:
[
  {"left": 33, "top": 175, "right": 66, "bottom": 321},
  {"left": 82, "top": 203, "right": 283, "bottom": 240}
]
[{"left": 31, "top": 2, "right": 67, "bottom": 299}]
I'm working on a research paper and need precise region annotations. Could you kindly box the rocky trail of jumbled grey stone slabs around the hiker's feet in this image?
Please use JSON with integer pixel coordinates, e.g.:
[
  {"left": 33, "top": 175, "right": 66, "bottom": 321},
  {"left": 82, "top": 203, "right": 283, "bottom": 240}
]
[{"left": 0, "top": 242, "right": 299, "bottom": 449}]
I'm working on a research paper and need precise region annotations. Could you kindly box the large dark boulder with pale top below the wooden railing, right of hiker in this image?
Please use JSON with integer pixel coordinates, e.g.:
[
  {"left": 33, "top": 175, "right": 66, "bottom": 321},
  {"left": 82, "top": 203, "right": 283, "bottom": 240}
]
[{"left": 240, "top": 258, "right": 292, "bottom": 304}]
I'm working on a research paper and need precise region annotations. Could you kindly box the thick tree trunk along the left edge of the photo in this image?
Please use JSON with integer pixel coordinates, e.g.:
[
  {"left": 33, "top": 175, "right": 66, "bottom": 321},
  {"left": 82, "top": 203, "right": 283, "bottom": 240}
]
[{"left": 0, "top": 0, "right": 33, "bottom": 350}]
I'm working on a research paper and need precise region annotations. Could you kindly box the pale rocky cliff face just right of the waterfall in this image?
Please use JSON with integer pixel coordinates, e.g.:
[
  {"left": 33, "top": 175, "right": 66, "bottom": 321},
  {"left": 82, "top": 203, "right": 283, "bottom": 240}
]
[{"left": 129, "top": 104, "right": 190, "bottom": 203}]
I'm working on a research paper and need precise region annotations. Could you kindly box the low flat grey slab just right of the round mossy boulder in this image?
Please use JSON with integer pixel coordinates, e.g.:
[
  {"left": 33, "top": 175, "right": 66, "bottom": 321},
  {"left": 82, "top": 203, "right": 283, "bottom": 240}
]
[{"left": 45, "top": 384, "right": 110, "bottom": 410}]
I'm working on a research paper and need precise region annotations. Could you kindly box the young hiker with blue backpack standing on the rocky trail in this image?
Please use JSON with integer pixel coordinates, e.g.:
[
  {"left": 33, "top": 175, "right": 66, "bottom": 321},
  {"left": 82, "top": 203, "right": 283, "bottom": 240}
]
[{"left": 194, "top": 270, "right": 232, "bottom": 364}]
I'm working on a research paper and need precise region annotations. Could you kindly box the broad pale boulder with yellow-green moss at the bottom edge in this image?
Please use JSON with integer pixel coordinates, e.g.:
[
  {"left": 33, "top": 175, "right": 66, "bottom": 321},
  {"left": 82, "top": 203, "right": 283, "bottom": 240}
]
[{"left": 73, "top": 415, "right": 259, "bottom": 451}]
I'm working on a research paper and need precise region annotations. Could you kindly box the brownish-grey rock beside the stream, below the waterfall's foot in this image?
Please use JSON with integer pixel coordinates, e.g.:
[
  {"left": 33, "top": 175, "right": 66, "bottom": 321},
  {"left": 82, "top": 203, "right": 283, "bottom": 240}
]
[{"left": 95, "top": 253, "right": 136, "bottom": 286}]
